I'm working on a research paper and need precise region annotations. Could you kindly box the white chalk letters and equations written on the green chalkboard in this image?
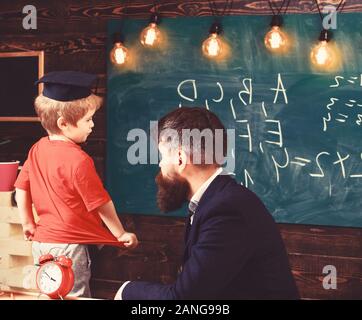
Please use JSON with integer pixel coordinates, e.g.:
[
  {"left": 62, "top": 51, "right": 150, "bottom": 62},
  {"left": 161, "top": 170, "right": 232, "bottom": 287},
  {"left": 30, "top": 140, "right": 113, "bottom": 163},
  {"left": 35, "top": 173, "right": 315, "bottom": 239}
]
[{"left": 176, "top": 73, "right": 362, "bottom": 189}]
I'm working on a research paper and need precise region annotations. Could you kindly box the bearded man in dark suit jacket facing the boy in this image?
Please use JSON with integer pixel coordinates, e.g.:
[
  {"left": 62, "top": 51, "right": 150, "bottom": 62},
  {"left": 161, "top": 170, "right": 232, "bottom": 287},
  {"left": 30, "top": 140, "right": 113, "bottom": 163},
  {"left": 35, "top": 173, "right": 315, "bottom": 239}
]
[{"left": 115, "top": 107, "right": 299, "bottom": 300}]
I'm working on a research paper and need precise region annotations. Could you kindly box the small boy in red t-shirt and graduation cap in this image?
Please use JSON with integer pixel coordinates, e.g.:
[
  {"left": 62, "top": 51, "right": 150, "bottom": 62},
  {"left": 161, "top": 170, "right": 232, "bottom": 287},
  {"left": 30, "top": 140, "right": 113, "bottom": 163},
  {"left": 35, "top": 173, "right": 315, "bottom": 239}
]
[{"left": 15, "top": 71, "right": 138, "bottom": 297}]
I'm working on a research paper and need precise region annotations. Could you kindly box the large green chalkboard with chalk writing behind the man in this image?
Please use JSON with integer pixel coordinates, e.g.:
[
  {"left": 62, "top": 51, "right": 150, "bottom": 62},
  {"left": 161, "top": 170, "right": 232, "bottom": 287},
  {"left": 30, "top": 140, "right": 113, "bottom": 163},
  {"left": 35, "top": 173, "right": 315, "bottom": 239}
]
[{"left": 106, "top": 13, "right": 362, "bottom": 227}]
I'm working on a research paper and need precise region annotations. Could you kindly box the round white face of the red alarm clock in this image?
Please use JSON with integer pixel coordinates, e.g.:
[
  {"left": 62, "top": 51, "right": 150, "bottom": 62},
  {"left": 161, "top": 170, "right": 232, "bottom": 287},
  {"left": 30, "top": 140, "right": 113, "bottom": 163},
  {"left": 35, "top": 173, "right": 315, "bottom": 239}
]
[{"left": 36, "top": 262, "right": 63, "bottom": 294}]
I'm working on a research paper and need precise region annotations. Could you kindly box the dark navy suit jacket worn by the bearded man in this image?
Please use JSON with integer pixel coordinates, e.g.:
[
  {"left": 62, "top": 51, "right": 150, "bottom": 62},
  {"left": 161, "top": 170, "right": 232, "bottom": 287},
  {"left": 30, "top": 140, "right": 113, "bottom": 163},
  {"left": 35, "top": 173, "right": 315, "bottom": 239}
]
[{"left": 122, "top": 175, "right": 299, "bottom": 300}]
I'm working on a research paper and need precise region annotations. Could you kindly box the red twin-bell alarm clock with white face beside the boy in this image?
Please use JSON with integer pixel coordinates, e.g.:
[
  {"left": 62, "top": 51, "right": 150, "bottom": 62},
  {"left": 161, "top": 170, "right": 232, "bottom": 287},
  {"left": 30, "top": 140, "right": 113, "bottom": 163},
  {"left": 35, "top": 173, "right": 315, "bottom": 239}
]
[{"left": 36, "top": 254, "right": 74, "bottom": 299}]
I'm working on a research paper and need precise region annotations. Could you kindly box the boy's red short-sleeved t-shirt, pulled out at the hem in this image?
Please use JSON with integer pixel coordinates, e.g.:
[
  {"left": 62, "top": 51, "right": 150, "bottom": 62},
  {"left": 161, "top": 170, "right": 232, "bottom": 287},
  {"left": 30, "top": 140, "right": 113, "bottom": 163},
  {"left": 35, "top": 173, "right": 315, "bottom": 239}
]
[{"left": 15, "top": 137, "right": 122, "bottom": 245}]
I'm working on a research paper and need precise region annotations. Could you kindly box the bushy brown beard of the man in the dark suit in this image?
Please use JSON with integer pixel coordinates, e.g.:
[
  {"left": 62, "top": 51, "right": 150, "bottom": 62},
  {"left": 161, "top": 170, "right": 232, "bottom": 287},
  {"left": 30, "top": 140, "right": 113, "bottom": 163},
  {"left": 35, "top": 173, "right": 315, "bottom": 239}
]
[{"left": 155, "top": 172, "right": 190, "bottom": 212}]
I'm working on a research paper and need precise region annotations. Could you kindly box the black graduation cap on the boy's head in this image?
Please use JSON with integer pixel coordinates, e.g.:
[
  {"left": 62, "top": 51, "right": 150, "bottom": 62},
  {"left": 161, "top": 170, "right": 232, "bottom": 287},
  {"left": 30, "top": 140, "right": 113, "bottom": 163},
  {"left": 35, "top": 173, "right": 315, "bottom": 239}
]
[{"left": 35, "top": 71, "right": 97, "bottom": 101}]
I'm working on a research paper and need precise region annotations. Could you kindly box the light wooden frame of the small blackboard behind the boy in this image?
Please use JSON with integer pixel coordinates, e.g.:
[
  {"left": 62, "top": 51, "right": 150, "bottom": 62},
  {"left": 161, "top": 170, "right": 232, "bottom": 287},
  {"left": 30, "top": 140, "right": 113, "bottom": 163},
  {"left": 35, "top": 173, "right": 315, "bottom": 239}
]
[{"left": 0, "top": 51, "right": 44, "bottom": 122}]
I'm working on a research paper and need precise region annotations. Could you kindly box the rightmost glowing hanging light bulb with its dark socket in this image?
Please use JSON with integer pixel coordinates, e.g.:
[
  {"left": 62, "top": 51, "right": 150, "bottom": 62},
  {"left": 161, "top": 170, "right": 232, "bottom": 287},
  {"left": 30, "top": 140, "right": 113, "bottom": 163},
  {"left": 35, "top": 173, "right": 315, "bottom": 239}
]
[{"left": 310, "top": 29, "right": 336, "bottom": 69}]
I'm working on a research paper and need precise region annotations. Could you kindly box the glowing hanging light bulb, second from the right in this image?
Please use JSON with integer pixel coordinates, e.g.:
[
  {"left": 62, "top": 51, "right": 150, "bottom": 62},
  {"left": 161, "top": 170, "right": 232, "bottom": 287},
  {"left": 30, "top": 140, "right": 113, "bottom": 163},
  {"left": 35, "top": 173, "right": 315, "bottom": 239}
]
[{"left": 264, "top": 15, "right": 290, "bottom": 53}]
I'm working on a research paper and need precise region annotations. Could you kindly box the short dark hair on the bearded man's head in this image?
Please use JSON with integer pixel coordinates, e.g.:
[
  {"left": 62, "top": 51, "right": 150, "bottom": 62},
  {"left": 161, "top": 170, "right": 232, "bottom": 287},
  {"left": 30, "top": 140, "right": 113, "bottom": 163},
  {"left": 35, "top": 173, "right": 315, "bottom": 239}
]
[{"left": 158, "top": 107, "right": 227, "bottom": 166}]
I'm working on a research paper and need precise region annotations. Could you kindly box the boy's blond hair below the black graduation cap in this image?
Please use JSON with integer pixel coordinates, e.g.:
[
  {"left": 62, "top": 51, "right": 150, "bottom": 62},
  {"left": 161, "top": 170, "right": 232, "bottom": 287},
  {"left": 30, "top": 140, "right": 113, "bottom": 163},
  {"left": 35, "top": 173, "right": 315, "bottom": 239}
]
[{"left": 35, "top": 94, "right": 103, "bottom": 134}]
